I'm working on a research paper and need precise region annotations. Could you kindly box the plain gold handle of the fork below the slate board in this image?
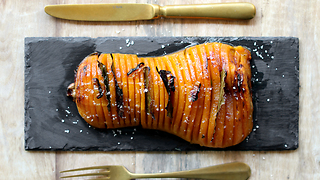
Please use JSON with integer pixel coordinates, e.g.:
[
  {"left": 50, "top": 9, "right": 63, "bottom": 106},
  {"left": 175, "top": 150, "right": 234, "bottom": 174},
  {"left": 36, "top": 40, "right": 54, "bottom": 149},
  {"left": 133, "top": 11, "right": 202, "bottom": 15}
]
[{"left": 130, "top": 162, "right": 251, "bottom": 180}]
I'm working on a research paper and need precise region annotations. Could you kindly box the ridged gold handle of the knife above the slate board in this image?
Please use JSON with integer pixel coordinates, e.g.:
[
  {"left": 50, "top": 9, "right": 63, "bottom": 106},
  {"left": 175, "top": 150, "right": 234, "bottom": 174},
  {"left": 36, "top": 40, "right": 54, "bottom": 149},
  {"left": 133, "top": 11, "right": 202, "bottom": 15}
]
[{"left": 159, "top": 3, "right": 256, "bottom": 20}]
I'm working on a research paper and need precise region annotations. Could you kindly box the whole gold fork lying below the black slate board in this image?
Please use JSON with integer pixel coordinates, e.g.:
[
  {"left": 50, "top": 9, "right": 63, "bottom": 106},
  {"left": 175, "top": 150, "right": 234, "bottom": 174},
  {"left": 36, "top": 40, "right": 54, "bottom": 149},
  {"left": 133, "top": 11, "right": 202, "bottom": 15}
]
[{"left": 60, "top": 162, "right": 251, "bottom": 180}]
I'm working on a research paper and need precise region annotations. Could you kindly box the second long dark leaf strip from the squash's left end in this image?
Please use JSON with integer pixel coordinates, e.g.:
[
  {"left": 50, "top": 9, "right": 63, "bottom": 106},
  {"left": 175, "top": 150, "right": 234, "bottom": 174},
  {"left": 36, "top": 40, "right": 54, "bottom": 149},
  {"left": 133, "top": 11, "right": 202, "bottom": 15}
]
[{"left": 110, "top": 54, "right": 124, "bottom": 118}]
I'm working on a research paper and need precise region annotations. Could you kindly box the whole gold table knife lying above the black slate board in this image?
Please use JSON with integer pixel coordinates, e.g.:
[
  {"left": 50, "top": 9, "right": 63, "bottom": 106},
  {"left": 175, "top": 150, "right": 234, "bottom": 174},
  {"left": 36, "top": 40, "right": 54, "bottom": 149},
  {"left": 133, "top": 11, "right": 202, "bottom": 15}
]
[{"left": 44, "top": 3, "right": 256, "bottom": 21}]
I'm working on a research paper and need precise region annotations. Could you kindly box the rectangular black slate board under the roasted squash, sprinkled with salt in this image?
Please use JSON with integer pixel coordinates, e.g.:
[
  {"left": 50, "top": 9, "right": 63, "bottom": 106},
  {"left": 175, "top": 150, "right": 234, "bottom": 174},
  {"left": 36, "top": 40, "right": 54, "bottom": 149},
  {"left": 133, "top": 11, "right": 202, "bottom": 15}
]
[{"left": 25, "top": 37, "right": 299, "bottom": 151}]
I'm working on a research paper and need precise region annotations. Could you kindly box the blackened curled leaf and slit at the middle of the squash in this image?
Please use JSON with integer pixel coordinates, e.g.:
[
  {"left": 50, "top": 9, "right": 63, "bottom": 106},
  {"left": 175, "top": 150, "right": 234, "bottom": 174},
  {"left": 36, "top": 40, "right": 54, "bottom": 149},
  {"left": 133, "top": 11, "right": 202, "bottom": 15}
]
[{"left": 156, "top": 66, "right": 176, "bottom": 118}]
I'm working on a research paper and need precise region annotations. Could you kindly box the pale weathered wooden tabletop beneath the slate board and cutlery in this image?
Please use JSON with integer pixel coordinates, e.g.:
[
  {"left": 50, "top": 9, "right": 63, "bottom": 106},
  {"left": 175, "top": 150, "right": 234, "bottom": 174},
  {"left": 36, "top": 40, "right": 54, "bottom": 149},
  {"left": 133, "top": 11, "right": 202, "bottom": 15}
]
[{"left": 0, "top": 0, "right": 320, "bottom": 179}]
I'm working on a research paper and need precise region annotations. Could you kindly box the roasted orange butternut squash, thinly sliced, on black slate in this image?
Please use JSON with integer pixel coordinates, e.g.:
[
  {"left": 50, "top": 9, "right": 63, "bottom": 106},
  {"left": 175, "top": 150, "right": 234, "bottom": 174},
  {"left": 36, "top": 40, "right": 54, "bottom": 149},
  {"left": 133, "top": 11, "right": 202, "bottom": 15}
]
[{"left": 67, "top": 43, "right": 253, "bottom": 148}]
